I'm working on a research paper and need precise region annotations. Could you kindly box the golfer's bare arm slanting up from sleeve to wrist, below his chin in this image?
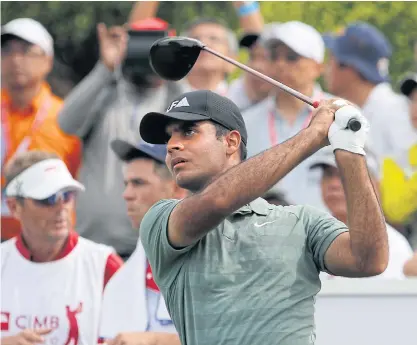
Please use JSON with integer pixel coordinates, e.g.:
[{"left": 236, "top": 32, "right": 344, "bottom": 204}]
[{"left": 169, "top": 128, "right": 320, "bottom": 245}]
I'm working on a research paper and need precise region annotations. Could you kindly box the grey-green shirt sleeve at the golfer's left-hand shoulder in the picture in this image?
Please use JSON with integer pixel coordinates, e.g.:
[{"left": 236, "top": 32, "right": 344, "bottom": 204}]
[{"left": 140, "top": 199, "right": 195, "bottom": 288}]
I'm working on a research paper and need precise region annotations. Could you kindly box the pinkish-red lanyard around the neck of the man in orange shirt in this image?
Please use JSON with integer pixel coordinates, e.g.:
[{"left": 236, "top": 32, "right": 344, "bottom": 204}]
[{"left": 1, "top": 95, "right": 52, "bottom": 169}]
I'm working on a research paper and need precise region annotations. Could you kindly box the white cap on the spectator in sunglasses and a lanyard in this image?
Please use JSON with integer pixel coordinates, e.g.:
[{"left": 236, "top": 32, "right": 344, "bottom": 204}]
[{"left": 268, "top": 21, "right": 325, "bottom": 63}]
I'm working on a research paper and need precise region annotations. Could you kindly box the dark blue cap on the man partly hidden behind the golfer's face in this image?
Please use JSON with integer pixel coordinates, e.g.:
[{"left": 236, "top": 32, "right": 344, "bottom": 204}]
[{"left": 110, "top": 139, "right": 167, "bottom": 163}]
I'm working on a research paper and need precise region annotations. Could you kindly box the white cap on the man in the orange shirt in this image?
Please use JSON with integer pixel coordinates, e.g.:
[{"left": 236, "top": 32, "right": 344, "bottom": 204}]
[{"left": 1, "top": 18, "right": 54, "bottom": 56}]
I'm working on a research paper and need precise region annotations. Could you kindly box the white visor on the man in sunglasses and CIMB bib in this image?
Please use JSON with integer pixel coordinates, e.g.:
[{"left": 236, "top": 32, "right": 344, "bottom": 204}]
[{"left": 6, "top": 158, "right": 85, "bottom": 200}]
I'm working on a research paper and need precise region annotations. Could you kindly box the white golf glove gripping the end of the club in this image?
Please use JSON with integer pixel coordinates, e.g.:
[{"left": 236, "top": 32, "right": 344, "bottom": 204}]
[{"left": 328, "top": 100, "right": 369, "bottom": 156}]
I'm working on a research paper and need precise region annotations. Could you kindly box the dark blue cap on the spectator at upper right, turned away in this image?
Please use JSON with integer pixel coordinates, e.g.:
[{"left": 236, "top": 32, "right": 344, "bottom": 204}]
[{"left": 323, "top": 22, "right": 392, "bottom": 84}]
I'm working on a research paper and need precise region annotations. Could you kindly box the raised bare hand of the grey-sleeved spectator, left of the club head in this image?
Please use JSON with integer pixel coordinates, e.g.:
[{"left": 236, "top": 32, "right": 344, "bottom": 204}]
[{"left": 97, "top": 23, "right": 128, "bottom": 71}]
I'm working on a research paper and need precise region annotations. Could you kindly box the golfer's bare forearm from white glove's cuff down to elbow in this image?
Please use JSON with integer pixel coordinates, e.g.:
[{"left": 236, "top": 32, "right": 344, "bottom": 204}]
[{"left": 335, "top": 150, "right": 388, "bottom": 272}]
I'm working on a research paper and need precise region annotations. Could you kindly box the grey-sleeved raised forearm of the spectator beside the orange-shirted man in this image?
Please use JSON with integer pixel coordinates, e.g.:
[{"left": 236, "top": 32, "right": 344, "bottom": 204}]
[{"left": 58, "top": 63, "right": 112, "bottom": 138}]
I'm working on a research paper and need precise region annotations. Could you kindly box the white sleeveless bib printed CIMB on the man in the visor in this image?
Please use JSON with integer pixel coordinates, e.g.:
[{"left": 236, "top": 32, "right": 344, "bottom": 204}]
[{"left": 1, "top": 232, "right": 121, "bottom": 345}]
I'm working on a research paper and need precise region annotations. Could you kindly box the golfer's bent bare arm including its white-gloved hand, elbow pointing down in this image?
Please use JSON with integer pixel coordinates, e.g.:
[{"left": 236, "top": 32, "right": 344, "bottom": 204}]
[{"left": 325, "top": 103, "right": 389, "bottom": 277}]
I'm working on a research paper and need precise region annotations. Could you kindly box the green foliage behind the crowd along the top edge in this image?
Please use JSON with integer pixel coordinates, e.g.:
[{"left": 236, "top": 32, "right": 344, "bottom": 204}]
[{"left": 1, "top": 1, "right": 417, "bottom": 95}]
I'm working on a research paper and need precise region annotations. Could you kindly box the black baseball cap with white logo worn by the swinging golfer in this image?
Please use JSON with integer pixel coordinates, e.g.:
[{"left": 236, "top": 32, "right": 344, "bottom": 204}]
[{"left": 139, "top": 90, "right": 248, "bottom": 145}]
